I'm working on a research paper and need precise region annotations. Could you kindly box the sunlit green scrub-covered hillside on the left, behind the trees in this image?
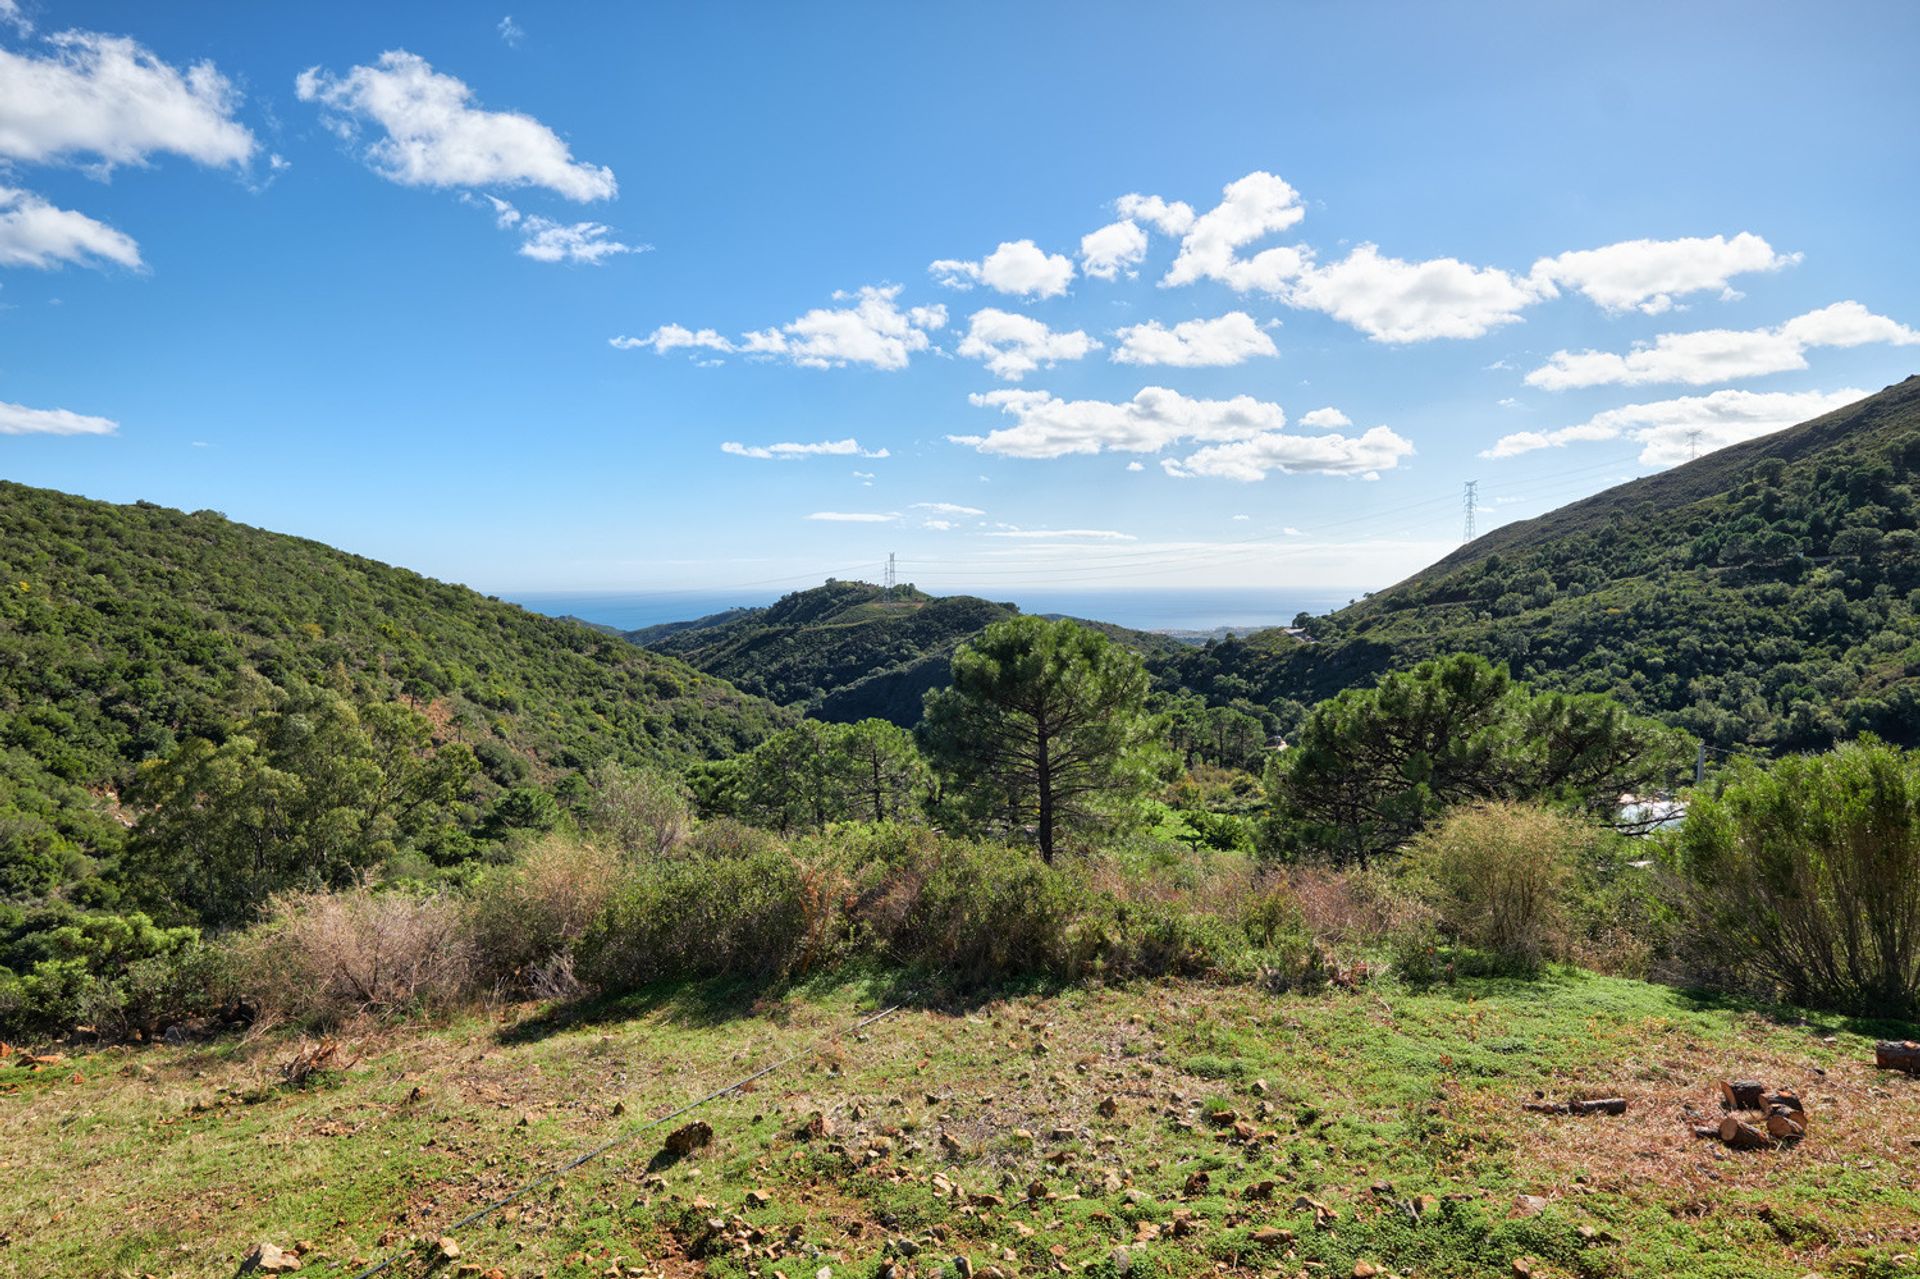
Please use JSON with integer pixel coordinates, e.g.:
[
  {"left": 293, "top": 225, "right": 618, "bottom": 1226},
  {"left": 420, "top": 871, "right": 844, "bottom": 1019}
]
[{"left": 0, "top": 484, "right": 785, "bottom": 891}]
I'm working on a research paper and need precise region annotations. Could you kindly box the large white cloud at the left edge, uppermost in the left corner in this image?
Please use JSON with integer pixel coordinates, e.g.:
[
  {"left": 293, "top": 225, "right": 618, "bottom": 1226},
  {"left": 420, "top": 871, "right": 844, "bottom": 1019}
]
[{"left": 0, "top": 31, "right": 255, "bottom": 171}]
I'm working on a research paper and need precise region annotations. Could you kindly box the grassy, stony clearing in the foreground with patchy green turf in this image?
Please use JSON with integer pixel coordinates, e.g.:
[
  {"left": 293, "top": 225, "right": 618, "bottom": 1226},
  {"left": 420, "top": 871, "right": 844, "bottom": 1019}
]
[{"left": 0, "top": 974, "right": 1920, "bottom": 1279}]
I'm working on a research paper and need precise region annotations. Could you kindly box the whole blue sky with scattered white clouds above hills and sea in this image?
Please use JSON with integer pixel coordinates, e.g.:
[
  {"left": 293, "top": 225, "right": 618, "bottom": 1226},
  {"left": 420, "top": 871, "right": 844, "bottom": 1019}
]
[{"left": 0, "top": 0, "right": 1920, "bottom": 597}]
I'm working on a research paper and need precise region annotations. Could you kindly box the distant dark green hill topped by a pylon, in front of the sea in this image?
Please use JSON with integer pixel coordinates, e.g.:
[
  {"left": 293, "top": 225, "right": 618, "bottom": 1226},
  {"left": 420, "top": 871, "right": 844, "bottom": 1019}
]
[{"left": 628, "top": 580, "right": 1179, "bottom": 728}]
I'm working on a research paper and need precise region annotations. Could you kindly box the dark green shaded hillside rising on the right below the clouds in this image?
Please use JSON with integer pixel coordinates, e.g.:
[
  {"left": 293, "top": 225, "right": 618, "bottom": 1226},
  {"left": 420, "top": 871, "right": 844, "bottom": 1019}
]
[{"left": 1162, "top": 368, "right": 1920, "bottom": 749}]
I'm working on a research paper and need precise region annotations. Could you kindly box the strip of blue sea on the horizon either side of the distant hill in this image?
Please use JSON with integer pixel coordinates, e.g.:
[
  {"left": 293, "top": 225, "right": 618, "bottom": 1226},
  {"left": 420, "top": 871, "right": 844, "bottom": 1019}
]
[{"left": 501, "top": 586, "right": 1361, "bottom": 634}]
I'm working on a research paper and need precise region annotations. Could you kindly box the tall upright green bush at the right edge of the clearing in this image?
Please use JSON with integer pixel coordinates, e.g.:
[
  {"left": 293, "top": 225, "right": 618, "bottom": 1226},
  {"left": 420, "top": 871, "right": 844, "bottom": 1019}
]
[{"left": 1668, "top": 737, "right": 1920, "bottom": 1018}]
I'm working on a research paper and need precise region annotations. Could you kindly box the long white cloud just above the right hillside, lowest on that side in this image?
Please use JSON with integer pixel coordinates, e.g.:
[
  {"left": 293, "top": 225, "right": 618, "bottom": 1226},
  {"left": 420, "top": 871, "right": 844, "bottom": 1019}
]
[{"left": 1480, "top": 388, "right": 1868, "bottom": 467}]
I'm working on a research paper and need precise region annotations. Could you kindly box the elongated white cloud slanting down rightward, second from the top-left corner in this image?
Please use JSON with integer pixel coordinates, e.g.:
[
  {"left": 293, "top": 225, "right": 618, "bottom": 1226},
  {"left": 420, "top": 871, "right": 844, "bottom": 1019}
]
[{"left": 294, "top": 50, "right": 618, "bottom": 202}]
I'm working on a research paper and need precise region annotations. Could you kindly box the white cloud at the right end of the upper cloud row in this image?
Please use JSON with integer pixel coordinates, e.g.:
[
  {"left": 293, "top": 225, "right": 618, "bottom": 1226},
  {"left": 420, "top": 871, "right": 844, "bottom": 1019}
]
[{"left": 1532, "top": 230, "right": 1801, "bottom": 315}]
